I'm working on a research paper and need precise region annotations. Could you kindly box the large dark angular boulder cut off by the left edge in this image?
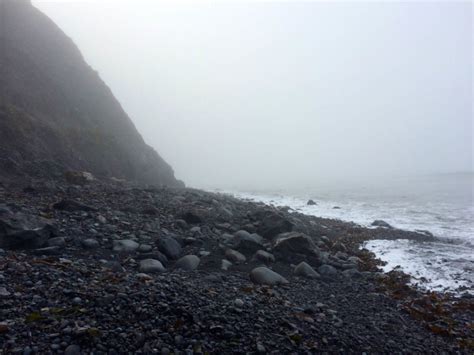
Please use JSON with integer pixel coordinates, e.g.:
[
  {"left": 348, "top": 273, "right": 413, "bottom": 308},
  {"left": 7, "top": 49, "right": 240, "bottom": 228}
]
[{"left": 0, "top": 210, "right": 54, "bottom": 249}]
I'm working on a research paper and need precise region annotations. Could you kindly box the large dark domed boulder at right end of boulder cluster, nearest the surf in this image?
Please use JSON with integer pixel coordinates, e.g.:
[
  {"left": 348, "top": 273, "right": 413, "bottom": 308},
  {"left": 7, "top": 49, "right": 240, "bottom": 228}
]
[{"left": 273, "top": 232, "right": 319, "bottom": 256}]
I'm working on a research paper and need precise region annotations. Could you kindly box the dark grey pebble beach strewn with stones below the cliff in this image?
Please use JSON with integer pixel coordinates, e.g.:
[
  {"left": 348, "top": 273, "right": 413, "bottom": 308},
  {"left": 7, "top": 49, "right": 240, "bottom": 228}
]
[{"left": 0, "top": 181, "right": 474, "bottom": 353}]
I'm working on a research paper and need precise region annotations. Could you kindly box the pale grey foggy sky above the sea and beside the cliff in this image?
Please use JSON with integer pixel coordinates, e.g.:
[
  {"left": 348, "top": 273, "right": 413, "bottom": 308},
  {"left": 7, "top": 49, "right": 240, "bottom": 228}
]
[{"left": 33, "top": 0, "right": 473, "bottom": 188}]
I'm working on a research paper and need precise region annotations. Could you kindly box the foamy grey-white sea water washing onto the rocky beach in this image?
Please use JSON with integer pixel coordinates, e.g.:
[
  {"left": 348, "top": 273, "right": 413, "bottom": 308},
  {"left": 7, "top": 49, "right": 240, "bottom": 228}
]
[{"left": 219, "top": 173, "right": 474, "bottom": 294}]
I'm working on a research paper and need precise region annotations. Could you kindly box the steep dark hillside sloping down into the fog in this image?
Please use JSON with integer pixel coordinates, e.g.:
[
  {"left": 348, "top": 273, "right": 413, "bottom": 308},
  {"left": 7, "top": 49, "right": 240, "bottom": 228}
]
[{"left": 0, "top": 0, "right": 182, "bottom": 186}]
